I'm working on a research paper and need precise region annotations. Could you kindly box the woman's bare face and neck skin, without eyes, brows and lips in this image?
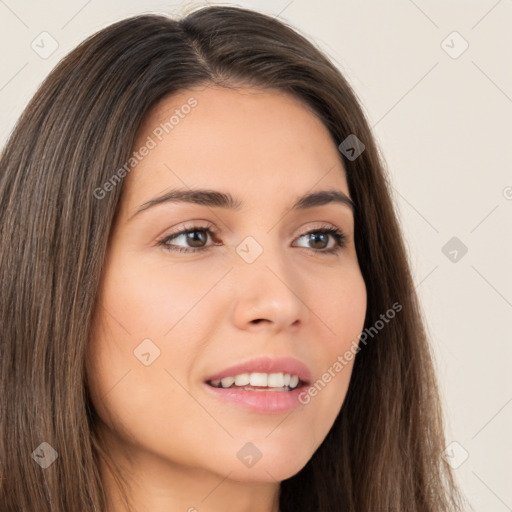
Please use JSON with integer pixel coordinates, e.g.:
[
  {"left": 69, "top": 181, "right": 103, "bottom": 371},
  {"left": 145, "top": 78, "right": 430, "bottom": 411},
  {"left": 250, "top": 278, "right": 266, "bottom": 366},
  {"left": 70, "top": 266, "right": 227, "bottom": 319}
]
[{"left": 87, "top": 86, "right": 366, "bottom": 512}]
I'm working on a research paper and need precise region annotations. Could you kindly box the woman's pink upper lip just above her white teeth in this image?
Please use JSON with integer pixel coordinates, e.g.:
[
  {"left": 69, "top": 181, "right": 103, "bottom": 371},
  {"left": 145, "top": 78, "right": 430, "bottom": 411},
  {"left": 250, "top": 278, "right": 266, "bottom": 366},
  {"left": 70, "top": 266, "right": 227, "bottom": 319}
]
[{"left": 206, "top": 356, "right": 311, "bottom": 384}]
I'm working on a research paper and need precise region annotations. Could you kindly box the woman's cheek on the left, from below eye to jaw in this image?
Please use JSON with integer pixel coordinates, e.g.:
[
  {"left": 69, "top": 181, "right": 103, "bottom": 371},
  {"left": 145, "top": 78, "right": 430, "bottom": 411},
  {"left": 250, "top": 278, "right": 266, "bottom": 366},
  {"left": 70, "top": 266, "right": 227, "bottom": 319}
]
[{"left": 87, "top": 253, "right": 228, "bottom": 448}]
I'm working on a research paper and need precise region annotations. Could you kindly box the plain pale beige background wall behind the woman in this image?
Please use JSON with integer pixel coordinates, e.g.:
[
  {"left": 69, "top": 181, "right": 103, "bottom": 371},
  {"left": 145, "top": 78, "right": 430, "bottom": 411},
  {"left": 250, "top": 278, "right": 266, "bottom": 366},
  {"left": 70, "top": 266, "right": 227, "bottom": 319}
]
[{"left": 0, "top": 0, "right": 512, "bottom": 512}]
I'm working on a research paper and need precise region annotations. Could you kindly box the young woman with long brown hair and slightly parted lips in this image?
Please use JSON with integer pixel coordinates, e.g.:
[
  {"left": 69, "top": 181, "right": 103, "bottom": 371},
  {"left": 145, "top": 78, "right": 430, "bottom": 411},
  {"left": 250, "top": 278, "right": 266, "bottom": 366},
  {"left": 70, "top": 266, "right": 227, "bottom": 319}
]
[{"left": 0, "top": 7, "right": 468, "bottom": 512}]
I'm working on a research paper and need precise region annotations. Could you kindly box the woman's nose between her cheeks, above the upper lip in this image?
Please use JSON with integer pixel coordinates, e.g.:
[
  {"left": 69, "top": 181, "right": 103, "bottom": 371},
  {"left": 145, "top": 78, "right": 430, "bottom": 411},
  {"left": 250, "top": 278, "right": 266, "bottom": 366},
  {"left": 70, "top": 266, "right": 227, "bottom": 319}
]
[{"left": 231, "top": 244, "right": 309, "bottom": 332}]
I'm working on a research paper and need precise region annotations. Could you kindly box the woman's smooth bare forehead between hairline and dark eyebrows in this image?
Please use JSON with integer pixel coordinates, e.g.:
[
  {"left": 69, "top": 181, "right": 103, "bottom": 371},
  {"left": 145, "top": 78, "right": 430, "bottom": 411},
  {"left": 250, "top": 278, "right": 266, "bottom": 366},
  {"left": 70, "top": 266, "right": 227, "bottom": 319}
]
[{"left": 124, "top": 87, "right": 348, "bottom": 209}]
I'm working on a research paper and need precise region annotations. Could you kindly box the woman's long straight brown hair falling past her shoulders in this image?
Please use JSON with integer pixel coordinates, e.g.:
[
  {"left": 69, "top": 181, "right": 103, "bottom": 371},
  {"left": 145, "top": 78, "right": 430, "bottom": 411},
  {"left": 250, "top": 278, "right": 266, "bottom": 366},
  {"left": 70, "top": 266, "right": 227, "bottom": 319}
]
[{"left": 0, "top": 6, "right": 463, "bottom": 512}]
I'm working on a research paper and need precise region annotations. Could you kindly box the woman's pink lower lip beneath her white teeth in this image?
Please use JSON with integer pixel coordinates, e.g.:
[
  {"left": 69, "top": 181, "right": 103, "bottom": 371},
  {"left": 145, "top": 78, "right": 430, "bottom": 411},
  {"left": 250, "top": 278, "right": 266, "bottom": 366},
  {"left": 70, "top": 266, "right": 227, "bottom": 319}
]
[{"left": 205, "top": 383, "right": 306, "bottom": 414}]
